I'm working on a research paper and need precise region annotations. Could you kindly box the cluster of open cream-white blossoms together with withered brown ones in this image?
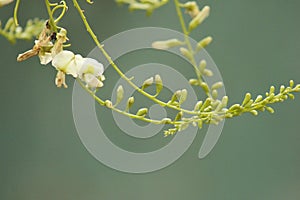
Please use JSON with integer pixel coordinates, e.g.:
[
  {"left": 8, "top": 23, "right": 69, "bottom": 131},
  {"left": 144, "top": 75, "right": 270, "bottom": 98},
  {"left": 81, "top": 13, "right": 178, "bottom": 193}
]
[{"left": 17, "top": 22, "right": 105, "bottom": 88}]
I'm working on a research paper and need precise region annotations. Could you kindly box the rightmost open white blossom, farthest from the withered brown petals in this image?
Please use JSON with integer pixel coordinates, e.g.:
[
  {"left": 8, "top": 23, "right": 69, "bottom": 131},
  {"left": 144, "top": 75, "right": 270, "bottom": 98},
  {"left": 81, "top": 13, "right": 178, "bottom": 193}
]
[{"left": 78, "top": 58, "right": 105, "bottom": 88}]
